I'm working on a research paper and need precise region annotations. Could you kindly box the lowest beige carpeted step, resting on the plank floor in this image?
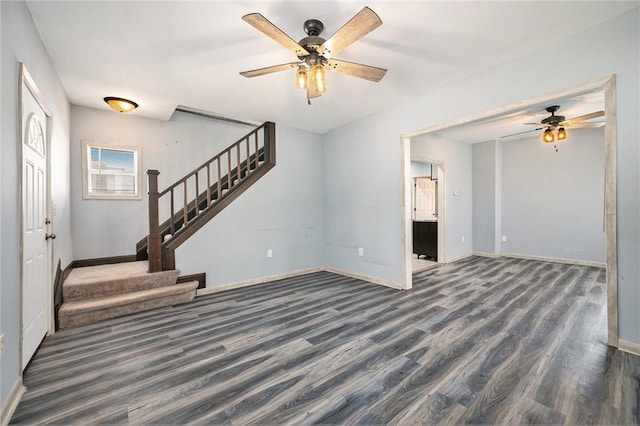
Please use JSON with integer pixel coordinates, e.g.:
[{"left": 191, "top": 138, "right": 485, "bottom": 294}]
[{"left": 58, "top": 281, "right": 198, "bottom": 328}]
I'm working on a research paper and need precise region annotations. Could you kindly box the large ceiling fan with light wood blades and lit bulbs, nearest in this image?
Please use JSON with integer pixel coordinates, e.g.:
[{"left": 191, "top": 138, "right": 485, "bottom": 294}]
[{"left": 240, "top": 6, "right": 387, "bottom": 105}]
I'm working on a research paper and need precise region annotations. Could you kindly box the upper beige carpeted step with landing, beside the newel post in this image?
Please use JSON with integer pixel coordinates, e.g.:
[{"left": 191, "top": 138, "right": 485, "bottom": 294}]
[{"left": 62, "top": 261, "right": 180, "bottom": 302}]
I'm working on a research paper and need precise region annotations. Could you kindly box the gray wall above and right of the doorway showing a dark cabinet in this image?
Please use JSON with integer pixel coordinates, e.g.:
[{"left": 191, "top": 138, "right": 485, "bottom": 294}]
[{"left": 411, "top": 135, "right": 473, "bottom": 262}]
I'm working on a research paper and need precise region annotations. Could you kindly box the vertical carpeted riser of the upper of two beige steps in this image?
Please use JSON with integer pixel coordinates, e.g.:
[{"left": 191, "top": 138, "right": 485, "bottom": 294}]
[{"left": 62, "top": 270, "right": 180, "bottom": 302}]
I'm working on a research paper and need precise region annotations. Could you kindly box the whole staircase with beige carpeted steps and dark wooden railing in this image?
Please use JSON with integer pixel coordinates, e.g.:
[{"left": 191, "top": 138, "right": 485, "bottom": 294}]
[{"left": 58, "top": 122, "right": 276, "bottom": 328}]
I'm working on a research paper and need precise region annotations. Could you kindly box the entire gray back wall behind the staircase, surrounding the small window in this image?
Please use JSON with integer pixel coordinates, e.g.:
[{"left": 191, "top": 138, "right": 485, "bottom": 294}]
[{"left": 71, "top": 106, "right": 324, "bottom": 287}]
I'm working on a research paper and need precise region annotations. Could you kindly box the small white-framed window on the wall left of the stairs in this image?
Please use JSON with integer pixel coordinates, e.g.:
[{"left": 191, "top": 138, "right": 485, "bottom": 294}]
[{"left": 82, "top": 140, "right": 142, "bottom": 200}]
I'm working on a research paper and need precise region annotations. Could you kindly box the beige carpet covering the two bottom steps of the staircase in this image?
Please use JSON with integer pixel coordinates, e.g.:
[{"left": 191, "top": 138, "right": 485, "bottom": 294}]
[{"left": 58, "top": 261, "right": 198, "bottom": 328}]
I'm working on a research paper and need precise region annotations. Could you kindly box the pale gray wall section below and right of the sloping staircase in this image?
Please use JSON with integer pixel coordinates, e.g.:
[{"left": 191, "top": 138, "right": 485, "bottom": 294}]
[{"left": 176, "top": 125, "right": 324, "bottom": 288}]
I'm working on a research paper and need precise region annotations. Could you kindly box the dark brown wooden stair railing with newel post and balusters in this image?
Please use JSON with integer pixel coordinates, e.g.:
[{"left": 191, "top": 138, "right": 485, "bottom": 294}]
[{"left": 142, "top": 122, "right": 276, "bottom": 272}]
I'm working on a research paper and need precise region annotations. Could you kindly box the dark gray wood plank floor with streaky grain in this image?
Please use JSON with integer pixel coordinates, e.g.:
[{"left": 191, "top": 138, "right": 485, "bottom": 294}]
[{"left": 11, "top": 257, "right": 640, "bottom": 424}]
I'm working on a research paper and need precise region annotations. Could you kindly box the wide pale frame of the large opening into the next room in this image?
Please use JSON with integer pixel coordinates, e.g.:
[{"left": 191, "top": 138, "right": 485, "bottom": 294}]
[{"left": 400, "top": 74, "right": 619, "bottom": 348}]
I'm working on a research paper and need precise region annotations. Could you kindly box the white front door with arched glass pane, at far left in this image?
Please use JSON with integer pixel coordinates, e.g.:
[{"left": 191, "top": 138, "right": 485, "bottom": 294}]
[{"left": 22, "top": 70, "right": 50, "bottom": 369}]
